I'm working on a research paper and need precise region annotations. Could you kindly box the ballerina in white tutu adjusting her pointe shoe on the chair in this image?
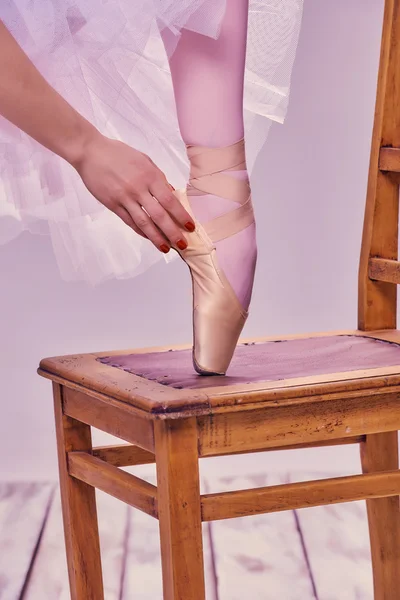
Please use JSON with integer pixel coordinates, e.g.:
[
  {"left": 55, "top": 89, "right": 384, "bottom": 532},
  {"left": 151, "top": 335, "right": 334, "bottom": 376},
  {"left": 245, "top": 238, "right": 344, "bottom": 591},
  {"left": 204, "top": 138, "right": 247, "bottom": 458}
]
[{"left": 0, "top": 0, "right": 302, "bottom": 374}]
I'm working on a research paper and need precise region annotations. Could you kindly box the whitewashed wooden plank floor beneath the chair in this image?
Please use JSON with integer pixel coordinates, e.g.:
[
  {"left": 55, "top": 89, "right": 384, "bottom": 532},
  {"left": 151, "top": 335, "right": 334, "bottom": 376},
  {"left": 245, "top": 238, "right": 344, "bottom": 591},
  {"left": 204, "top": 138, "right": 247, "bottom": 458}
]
[{"left": 0, "top": 475, "right": 372, "bottom": 600}]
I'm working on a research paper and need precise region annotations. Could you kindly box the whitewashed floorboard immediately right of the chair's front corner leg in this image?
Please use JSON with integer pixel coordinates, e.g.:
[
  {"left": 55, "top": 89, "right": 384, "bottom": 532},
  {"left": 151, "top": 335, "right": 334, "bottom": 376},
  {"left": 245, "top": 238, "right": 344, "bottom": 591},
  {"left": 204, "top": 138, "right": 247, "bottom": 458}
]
[{"left": 209, "top": 475, "right": 316, "bottom": 600}]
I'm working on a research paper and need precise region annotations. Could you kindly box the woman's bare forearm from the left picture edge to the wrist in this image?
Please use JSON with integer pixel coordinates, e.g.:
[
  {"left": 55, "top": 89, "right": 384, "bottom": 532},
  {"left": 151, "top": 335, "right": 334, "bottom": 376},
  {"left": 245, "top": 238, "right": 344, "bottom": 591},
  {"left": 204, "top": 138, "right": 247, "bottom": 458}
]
[{"left": 0, "top": 21, "right": 98, "bottom": 165}]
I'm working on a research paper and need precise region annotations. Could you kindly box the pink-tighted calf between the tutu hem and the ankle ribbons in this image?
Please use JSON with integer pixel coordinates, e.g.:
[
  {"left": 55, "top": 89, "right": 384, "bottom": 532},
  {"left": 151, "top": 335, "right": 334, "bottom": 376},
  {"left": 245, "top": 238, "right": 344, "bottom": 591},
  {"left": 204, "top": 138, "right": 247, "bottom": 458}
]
[{"left": 170, "top": 0, "right": 249, "bottom": 147}]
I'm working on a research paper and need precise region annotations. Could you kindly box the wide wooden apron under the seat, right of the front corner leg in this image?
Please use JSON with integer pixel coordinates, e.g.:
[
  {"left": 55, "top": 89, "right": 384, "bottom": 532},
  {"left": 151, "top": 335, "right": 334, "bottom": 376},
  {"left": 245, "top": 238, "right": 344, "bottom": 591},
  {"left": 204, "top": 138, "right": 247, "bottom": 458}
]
[{"left": 198, "top": 393, "right": 400, "bottom": 456}]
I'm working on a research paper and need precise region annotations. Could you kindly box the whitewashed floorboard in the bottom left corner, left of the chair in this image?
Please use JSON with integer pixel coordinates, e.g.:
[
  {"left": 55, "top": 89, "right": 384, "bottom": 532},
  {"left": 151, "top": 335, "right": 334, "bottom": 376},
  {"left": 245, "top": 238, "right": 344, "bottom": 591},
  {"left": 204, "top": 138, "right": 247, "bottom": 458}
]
[{"left": 0, "top": 483, "right": 54, "bottom": 600}]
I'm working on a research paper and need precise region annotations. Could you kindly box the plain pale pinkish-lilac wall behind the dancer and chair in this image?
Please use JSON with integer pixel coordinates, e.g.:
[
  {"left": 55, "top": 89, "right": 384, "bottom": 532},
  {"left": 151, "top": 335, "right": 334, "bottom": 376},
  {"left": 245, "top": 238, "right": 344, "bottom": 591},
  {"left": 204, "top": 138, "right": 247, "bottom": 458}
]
[{"left": 0, "top": 0, "right": 386, "bottom": 479}]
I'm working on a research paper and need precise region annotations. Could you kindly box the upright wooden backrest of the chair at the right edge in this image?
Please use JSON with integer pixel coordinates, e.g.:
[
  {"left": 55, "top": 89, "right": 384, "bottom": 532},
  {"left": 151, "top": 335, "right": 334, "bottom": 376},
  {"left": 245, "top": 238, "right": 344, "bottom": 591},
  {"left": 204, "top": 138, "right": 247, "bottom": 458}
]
[{"left": 360, "top": 0, "right": 400, "bottom": 331}]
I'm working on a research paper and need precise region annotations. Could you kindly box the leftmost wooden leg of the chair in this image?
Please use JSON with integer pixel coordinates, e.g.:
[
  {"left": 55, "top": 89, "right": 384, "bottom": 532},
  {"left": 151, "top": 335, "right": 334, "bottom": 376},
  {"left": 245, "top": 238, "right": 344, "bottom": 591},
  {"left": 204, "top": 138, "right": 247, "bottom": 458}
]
[{"left": 53, "top": 383, "right": 104, "bottom": 600}]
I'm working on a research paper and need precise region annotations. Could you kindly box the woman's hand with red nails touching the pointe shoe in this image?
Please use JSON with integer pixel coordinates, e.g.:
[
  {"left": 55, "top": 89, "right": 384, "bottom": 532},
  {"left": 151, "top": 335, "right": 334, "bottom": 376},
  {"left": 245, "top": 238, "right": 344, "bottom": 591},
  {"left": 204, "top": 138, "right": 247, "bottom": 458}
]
[{"left": 73, "top": 132, "right": 194, "bottom": 253}]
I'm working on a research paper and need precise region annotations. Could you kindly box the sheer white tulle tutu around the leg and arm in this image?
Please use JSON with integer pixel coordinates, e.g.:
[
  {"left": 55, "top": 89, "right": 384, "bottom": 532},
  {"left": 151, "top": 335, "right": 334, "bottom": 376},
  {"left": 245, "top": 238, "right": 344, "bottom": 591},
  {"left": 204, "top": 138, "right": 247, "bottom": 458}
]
[{"left": 0, "top": 0, "right": 303, "bottom": 284}]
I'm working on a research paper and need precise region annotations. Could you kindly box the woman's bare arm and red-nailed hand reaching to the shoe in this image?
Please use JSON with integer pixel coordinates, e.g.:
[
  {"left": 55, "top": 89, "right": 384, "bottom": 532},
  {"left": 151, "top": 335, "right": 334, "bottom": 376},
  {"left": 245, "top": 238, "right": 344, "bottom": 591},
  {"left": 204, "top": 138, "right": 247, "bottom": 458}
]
[{"left": 0, "top": 21, "right": 194, "bottom": 252}]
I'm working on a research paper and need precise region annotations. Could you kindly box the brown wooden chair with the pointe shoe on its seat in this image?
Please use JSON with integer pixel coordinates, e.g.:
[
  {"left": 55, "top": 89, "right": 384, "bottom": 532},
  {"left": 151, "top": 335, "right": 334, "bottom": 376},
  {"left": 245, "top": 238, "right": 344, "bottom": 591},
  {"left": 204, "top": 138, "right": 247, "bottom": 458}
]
[{"left": 39, "top": 0, "right": 400, "bottom": 600}]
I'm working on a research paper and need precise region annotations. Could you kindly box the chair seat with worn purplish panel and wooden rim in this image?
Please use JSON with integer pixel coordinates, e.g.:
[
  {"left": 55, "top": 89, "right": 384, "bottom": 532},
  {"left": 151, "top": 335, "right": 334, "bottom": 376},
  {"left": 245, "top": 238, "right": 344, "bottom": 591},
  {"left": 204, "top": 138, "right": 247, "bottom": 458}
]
[{"left": 40, "top": 330, "right": 400, "bottom": 413}]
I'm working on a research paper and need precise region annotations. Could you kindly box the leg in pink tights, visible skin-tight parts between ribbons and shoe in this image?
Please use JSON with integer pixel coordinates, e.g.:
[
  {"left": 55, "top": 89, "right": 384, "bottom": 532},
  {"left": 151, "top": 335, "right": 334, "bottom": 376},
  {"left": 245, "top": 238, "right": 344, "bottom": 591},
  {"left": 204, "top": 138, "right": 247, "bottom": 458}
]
[{"left": 161, "top": 0, "right": 257, "bottom": 309}]
